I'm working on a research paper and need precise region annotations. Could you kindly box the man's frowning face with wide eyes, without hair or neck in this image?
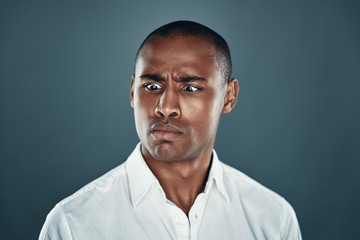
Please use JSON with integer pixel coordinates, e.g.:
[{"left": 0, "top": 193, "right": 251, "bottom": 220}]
[{"left": 131, "top": 36, "right": 232, "bottom": 162}]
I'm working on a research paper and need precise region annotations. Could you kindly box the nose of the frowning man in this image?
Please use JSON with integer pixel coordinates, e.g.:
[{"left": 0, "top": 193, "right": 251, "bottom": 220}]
[{"left": 155, "top": 88, "right": 181, "bottom": 118}]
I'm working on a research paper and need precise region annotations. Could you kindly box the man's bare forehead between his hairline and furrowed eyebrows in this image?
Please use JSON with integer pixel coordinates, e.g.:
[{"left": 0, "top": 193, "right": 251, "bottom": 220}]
[{"left": 136, "top": 36, "right": 217, "bottom": 75}]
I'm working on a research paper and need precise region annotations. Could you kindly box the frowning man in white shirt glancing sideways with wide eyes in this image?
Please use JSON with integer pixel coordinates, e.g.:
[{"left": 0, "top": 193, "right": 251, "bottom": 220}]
[{"left": 40, "top": 21, "right": 301, "bottom": 239}]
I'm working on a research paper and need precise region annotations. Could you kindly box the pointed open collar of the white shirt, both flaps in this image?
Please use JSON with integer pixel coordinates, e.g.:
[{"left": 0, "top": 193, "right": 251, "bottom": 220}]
[{"left": 126, "top": 143, "right": 230, "bottom": 207}]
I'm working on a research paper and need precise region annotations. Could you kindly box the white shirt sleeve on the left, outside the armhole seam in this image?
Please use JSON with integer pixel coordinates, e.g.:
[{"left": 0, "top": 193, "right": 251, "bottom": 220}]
[{"left": 39, "top": 204, "right": 73, "bottom": 240}]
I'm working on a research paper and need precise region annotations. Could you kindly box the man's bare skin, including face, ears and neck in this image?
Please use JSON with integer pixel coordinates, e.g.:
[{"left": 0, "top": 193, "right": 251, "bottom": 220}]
[{"left": 130, "top": 36, "right": 239, "bottom": 214}]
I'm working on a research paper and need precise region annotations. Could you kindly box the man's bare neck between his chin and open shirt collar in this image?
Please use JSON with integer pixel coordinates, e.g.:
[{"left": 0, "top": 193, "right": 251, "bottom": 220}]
[{"left": 145, "top": 147, "right": 212, "bottom": 215}]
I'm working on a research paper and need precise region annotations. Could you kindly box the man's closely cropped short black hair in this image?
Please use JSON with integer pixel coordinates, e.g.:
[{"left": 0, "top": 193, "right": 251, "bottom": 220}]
[{"left": 135, "top": 21, "right": 232, "bottom": 82}]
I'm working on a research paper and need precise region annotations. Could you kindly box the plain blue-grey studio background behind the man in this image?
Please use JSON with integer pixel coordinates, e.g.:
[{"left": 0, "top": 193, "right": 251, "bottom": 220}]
[{"left": 0, "top": 0, "right": 360, "bottom": 239}]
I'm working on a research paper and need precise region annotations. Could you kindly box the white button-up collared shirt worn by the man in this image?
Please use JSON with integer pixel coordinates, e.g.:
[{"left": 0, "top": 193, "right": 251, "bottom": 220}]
[{"left": 39, "top": 143, "right": 301, "bottom": 240}]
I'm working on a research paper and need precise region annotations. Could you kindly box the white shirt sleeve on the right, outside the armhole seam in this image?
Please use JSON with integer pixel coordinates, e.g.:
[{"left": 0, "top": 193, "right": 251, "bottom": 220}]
[{"left": 281, "top": 202, "right": 302, "bottom": 240}]
